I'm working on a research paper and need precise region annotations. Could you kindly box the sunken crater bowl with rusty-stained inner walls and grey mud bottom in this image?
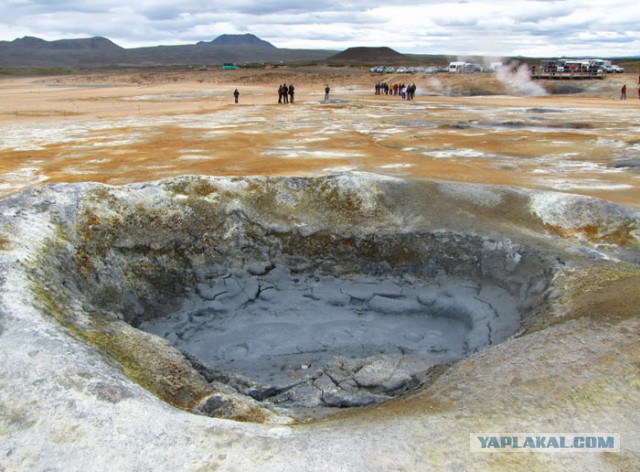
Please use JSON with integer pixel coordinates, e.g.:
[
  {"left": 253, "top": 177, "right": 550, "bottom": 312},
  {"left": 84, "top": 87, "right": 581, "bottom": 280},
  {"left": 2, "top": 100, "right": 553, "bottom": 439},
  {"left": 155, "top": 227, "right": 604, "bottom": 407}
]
[{"left": 35, "top": 176, "right": 549, "bottom": 417}]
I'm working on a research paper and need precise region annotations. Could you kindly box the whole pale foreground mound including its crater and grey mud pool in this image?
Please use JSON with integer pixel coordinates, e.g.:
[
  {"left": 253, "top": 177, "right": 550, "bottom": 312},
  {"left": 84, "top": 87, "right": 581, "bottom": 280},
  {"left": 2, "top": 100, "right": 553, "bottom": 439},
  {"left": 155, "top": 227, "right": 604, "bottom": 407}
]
[{"left": 0, "top": 173, "right": 640, "bottom": 471}]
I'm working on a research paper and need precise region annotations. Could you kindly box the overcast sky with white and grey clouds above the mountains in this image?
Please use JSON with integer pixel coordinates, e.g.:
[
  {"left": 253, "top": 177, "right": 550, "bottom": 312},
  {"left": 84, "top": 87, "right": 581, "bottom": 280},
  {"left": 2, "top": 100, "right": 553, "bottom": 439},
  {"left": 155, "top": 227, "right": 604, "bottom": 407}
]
[{"left": 0, "top": 0, "right": 640, "bottom": 57}]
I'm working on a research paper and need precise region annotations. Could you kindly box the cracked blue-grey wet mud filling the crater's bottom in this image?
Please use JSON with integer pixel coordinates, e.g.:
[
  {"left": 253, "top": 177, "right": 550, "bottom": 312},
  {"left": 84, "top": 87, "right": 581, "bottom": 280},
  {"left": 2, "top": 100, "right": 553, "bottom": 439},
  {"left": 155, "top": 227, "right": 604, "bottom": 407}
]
[{"left": 138, "top": 260, "right": 520, "bottom": 407}]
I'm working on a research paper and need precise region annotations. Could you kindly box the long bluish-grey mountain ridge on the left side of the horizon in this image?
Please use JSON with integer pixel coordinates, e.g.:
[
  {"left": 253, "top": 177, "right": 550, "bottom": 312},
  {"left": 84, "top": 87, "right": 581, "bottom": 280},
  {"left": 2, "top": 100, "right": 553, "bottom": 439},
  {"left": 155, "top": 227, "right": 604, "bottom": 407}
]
[{"left": 0, "top": 34, "right": 336, "bottom": 68}]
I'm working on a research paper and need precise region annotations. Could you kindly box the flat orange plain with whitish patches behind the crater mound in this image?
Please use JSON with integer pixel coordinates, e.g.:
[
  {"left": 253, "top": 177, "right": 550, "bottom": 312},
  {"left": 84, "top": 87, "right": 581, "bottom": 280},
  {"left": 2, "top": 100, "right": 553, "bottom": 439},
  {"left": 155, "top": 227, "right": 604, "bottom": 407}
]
[{"left": 0, "top": 67, "right": 640, "bottom": 206}]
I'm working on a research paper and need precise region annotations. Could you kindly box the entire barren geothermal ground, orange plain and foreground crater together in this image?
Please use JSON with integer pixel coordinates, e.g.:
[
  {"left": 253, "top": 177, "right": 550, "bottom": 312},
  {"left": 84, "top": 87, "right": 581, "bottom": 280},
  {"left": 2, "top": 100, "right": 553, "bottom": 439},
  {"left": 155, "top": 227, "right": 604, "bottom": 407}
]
[{"left": 0, "top": 66, "right": 640, "bottom": 471}]
